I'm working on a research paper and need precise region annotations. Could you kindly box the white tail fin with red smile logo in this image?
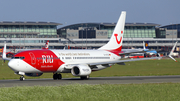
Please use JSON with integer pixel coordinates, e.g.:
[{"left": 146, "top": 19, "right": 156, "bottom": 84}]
[{"left": 99, "top": 11, "right": 126, "bottom": 51}]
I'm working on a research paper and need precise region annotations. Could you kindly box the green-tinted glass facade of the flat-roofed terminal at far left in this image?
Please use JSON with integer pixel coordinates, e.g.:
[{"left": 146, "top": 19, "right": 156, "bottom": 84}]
[{"left": 0, "top": 22, "right": 59, "bottom": 38}]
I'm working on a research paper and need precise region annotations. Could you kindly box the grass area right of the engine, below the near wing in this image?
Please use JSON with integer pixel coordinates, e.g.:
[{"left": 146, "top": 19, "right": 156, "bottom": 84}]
[{"left": 92, "top": 59, "right": 180, "bottom": 76}]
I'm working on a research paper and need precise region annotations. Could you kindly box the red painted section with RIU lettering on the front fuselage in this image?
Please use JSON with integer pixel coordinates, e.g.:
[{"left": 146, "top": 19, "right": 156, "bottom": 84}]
[{"left": 15, "top": 49, "right": 64, "bottom": 72}]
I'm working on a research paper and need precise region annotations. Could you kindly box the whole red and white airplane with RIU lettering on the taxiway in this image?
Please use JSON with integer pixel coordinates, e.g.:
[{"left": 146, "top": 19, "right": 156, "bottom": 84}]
[{"left": 3, "top": 11, "right": 161, "bottom": 81}]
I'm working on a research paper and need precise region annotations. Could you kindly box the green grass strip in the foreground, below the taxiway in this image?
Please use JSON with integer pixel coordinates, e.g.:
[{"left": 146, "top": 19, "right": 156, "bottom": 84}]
[{"left": 0, "top": 83, "right": 180, "bottom": 101}]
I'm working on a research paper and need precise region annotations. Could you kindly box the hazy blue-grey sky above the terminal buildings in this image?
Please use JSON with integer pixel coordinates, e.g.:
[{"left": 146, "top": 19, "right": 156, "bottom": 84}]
[{"left": 0, "top": 0, "right": 180, "bottom": 27}]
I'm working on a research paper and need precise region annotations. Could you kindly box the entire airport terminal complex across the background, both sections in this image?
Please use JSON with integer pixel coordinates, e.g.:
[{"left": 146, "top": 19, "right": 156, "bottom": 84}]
[{"left": 0, "top": 21, "right": 180, "bottom": 51}]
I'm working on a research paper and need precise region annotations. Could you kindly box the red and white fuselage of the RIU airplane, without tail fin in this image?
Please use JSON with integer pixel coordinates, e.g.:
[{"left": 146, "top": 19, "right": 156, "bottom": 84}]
[{"left": 8, "top": 50, "right": 121, "bottom": 73}]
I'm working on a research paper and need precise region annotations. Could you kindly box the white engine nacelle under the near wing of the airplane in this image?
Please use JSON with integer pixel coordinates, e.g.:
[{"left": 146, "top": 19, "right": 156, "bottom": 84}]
[{"left": 71, "top": 65, "right": 91, "bottom": 76}]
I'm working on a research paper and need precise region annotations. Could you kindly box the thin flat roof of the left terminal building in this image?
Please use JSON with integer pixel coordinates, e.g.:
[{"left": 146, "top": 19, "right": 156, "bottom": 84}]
[{"left": 0, "top": 21, "right": 62, "bottom": 26}]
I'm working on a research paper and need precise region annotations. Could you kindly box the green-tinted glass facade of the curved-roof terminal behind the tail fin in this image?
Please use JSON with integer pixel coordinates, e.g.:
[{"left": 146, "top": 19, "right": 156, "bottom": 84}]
[{"left": 58, "top": 23, "right": 159, "bottom": 38}]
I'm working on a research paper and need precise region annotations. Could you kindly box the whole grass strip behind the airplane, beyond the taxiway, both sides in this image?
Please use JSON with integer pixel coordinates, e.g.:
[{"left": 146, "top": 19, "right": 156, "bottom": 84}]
[{"left": 0, "top": 59, "right": 180, "bottom": 79}]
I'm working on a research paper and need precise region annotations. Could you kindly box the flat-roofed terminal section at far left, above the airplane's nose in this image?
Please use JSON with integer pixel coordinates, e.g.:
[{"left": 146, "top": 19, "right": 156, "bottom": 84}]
[{"left": 0, "top": 21, "right": 62, "bottom": 48}]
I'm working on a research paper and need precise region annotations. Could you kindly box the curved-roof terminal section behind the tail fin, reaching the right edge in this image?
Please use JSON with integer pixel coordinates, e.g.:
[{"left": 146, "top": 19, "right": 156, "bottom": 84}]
[{"left": 57, "top": 23, "right": 180, "bottom": 51}]
